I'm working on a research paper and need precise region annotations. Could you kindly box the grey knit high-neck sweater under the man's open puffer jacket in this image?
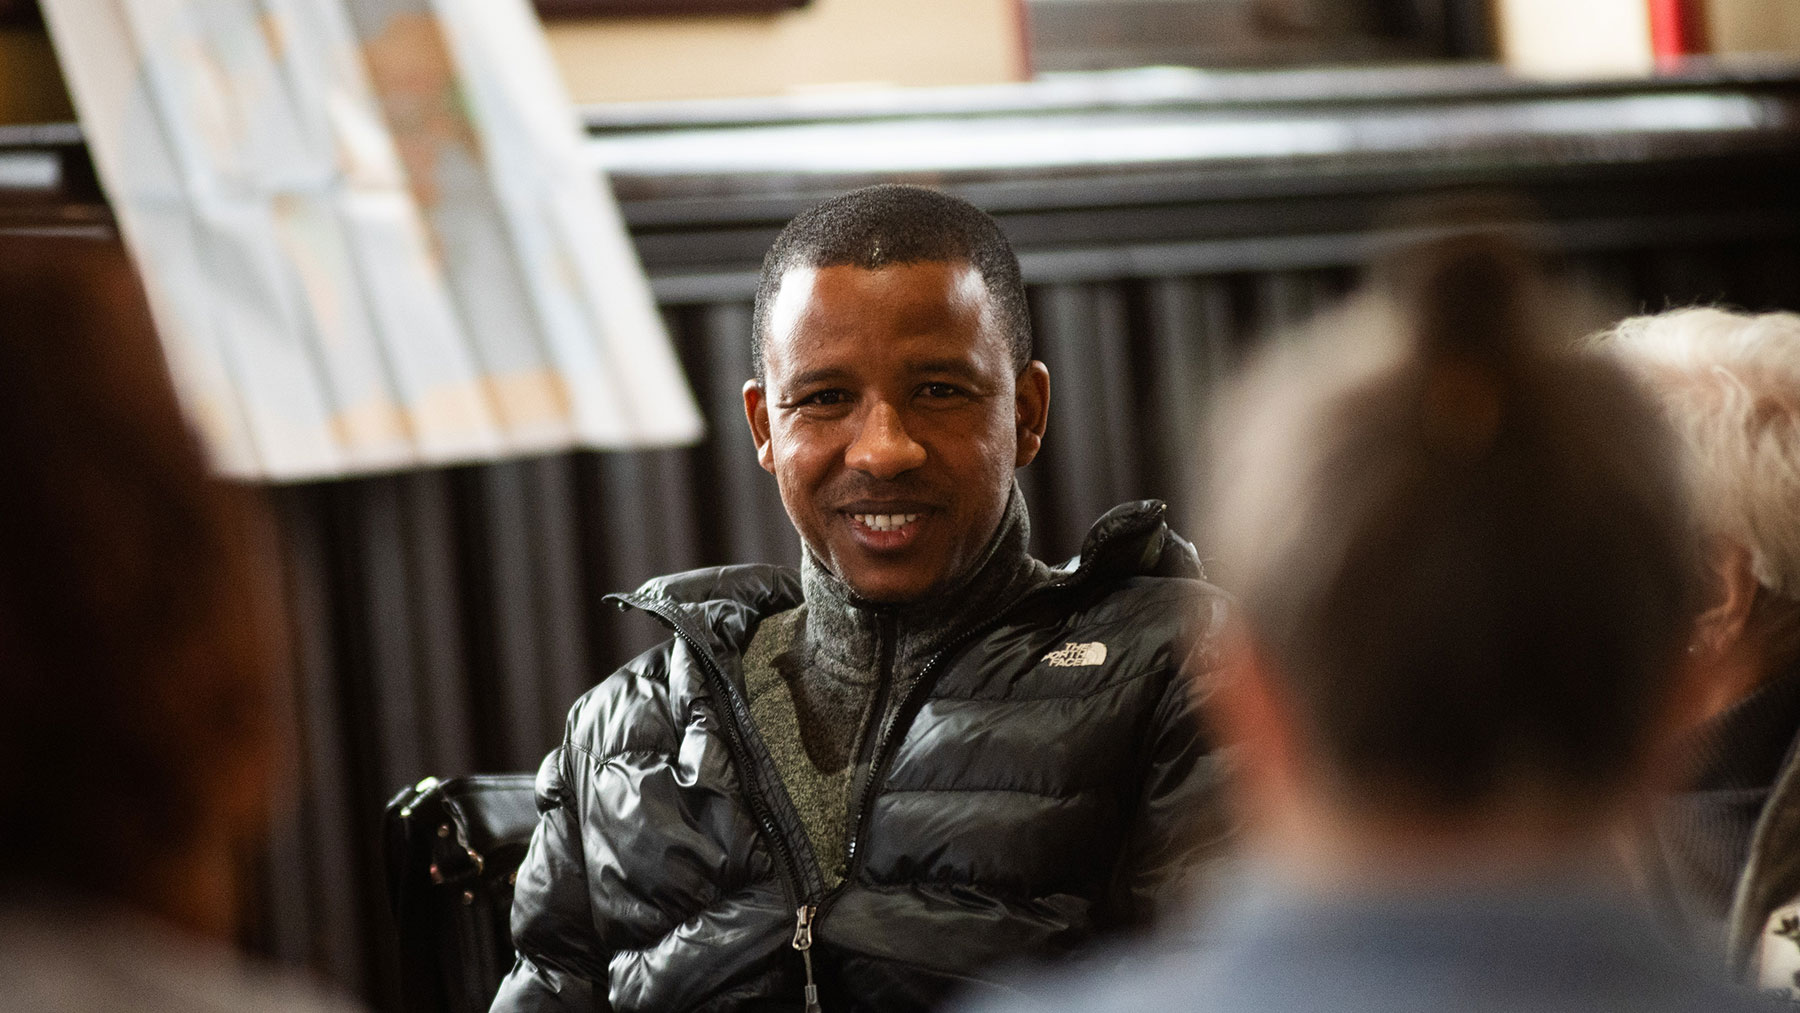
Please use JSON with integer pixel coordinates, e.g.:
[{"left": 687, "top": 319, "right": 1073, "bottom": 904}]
[{"left": 743, "top": 484, "right": 1049, "bottom": 885}]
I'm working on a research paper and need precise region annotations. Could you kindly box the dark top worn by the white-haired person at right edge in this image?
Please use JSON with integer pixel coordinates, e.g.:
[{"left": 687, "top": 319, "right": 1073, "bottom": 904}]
[{"left": 1656, "top": 668, "right": 1800, "bottom": 946}]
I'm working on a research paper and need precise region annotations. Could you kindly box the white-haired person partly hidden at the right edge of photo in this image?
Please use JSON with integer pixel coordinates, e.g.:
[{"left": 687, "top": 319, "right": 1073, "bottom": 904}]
[{"left": 1595, "top": 308, "right": 1800, "bottom": 997}]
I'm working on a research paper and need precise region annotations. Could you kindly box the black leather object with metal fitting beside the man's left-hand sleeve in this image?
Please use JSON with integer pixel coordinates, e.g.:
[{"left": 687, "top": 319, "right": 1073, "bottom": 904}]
[{"left": 383, "top": 774, "right": 538, "bottom": 1013}]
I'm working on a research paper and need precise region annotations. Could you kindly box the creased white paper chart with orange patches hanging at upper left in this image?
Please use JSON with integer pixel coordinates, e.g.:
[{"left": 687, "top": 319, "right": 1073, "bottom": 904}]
[{"left": 43, "top": 0, "right": 700, "bottom": 482}]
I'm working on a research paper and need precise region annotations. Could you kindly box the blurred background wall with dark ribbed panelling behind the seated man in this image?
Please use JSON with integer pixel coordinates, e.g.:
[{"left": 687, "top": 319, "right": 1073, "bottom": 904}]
[{"left": 0, "top": 0, "right": 1800, "bottom": 1008}]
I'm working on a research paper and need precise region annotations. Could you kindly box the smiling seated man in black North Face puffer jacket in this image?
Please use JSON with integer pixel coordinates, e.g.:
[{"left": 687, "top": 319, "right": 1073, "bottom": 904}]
[{"left": 493, "top": 187, "right": 1219, "bottom": 1013}]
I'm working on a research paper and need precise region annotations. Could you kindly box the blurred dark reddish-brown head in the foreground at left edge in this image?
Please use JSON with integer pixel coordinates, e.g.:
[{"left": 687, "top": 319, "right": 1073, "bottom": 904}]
[{"left": 0, "top": 238, "right": 275, "bottom": 936}]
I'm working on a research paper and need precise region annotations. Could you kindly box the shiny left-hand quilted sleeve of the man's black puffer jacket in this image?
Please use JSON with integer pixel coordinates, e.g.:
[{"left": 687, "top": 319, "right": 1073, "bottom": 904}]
[{"left": 491, "top": 749, "right": 608, "bottom": 1013}]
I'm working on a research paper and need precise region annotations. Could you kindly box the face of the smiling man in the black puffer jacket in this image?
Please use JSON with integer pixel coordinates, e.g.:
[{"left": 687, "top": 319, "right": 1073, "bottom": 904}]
[{"left": 743, "top": 263, "right": 1049, "bottom": 603}]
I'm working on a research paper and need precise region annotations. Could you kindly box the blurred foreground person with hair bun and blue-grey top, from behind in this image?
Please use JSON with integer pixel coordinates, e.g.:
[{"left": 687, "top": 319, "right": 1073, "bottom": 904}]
[{"left": 964, "top": 236, "right": 1760, "bottom": 1013}]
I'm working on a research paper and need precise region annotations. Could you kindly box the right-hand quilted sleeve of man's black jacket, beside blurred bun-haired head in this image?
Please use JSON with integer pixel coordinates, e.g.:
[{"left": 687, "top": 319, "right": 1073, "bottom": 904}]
[{"left": 1116, "top": 597, "right": 1235, "bottom": 927}]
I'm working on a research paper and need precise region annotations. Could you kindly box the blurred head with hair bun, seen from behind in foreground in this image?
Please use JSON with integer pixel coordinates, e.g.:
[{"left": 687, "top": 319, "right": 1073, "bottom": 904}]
[{"left": 1208, "top": 234, "right": 1694, "bottom": 882}]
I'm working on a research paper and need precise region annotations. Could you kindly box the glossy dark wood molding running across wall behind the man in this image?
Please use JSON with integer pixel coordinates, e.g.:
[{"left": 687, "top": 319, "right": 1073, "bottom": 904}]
[{"left": 17, "top": 63, "right": 1800, "bottom": 293}]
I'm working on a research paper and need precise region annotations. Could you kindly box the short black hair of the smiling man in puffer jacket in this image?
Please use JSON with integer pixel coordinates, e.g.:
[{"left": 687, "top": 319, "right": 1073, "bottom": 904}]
[{"left": 751, "top": 184, "right": 1031, "bottom": 380}]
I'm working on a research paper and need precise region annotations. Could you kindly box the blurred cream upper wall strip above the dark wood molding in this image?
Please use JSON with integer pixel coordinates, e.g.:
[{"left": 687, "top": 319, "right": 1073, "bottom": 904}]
[{"left": 10, "top": 0, "right": 1800, "bottom": 122}]
